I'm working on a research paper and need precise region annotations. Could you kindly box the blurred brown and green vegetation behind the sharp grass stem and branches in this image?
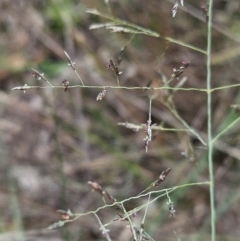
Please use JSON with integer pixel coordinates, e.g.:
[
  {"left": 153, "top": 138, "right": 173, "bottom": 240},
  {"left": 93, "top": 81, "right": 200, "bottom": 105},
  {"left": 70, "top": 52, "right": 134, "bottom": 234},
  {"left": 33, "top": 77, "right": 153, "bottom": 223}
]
[{"left": 0, "top": 0, "right": 240, "bottom": 241}]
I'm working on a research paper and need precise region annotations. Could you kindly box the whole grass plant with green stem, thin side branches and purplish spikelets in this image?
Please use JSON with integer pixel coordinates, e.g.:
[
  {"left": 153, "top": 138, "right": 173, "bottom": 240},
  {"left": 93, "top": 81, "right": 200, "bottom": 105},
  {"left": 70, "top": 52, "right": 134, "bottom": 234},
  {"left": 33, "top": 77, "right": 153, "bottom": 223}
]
[{"left": 7, "top": 0, "right": 240, "bottom": 241}]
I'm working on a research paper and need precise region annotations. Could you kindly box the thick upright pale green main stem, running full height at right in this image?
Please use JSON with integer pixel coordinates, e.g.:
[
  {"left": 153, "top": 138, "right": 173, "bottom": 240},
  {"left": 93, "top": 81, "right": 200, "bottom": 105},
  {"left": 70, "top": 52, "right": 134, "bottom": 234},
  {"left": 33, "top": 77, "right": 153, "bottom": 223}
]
[{"left": 207, "top": 0, "right": 216, "bottom": 241}]
